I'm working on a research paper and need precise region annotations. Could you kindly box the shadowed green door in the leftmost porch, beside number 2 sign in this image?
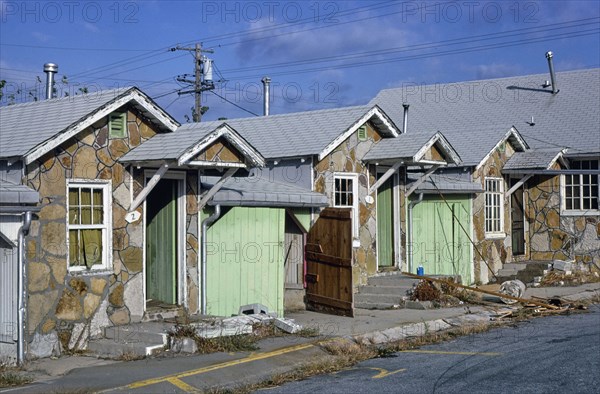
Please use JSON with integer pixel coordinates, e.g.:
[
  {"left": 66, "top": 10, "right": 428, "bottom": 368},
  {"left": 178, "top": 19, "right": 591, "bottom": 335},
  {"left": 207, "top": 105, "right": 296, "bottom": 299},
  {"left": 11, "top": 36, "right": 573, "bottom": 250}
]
[{"left": 146, "top": 179, "right": 178, "bottom": 304}]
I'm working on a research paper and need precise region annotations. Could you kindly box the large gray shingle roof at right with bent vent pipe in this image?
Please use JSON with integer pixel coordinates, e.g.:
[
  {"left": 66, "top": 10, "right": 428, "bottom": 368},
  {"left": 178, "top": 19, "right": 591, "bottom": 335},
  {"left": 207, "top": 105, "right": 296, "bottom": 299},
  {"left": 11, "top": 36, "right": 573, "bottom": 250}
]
[{"left": 371, "top": 68, "right": 600, "bottom": 157}]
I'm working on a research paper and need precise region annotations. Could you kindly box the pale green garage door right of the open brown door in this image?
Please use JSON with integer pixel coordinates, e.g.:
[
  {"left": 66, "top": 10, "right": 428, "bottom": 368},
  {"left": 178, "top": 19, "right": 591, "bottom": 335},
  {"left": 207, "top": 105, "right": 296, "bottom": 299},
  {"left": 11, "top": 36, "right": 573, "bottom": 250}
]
[{"left": 412, "top": 196, "right": 473, "bottom": 283}]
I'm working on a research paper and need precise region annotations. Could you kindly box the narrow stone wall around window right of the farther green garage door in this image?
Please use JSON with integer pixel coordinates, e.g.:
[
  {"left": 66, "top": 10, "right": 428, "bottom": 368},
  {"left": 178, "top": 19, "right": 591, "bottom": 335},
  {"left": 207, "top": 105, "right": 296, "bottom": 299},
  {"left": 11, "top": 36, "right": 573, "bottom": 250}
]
[{"left": 473, "top": 142, "right": 515, "bottom": 283}]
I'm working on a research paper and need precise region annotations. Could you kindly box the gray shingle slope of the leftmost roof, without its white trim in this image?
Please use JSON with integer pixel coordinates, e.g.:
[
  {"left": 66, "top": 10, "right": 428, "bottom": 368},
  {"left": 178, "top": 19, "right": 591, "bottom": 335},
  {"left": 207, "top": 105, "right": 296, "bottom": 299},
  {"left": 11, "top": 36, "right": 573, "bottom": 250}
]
[{"left": 0, "top": 87, "right": 177, "bottom": 157}]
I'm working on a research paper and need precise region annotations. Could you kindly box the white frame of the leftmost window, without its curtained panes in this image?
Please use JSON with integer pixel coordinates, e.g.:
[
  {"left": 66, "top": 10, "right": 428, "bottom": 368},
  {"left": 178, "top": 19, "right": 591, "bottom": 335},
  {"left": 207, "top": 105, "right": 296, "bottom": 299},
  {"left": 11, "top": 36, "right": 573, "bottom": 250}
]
[{"left": 66, "top": 179, "right": 112, "bottom": 273}]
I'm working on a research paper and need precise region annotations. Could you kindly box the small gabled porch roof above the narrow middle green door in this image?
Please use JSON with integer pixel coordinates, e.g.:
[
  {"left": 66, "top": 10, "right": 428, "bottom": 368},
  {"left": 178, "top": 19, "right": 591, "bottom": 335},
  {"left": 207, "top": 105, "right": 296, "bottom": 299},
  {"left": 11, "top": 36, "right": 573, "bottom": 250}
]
[{"left": 364, "top": 132, "right": 461, "bottom": 164}]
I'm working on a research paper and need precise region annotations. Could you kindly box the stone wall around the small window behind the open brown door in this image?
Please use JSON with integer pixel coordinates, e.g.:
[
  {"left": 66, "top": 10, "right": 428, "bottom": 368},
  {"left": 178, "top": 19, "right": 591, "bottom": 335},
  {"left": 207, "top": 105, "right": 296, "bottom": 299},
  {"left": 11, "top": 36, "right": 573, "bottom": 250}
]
[{"left": 314, "top": 124, "right": 381, "bottom": 289}]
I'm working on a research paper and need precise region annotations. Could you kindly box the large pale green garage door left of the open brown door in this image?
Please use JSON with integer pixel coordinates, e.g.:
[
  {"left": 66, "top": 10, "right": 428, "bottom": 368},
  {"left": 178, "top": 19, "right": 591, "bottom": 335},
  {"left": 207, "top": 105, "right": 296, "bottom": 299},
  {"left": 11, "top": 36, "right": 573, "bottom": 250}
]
[{"left": 206, "top": 207, "right": 285, "bottom": 316}]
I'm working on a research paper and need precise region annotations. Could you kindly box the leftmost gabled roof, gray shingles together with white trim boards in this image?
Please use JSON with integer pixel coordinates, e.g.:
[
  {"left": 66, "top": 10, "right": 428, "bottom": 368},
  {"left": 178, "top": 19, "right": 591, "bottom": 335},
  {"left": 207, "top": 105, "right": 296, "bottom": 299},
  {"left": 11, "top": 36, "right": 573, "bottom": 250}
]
[{"left": 0, "top": 87, "right": 179, "bottom": 164}]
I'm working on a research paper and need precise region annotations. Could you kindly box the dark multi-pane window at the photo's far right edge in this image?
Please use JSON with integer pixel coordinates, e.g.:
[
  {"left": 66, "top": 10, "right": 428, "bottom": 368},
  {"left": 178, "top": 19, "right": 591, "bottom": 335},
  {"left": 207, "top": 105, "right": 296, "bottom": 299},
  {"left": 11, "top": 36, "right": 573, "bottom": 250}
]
[{"left": 563, "top": 160, "right": 599, "bottom": 212}]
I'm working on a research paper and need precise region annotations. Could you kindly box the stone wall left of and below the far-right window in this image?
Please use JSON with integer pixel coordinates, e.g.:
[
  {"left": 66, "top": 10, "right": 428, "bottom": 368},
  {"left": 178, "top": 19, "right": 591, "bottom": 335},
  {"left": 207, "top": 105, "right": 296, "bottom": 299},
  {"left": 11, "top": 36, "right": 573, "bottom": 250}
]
[{"left": 525, "top": 175, "right": 600, "bottom": 271}]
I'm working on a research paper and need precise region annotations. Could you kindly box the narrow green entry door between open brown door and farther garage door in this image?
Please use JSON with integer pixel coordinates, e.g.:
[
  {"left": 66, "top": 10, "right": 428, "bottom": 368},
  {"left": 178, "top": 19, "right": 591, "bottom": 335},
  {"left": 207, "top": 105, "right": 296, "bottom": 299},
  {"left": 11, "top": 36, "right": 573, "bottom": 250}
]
[{"left": 377, "top": 178, "right": 394, "bottom": 268}]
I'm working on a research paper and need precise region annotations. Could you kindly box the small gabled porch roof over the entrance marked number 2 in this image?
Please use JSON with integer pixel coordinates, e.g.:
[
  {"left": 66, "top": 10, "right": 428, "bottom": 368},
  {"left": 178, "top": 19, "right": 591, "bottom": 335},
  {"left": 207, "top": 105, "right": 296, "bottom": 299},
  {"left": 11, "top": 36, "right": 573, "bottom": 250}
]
[{"left": 120, "top": 121, "right": 265, "bottom": 167}]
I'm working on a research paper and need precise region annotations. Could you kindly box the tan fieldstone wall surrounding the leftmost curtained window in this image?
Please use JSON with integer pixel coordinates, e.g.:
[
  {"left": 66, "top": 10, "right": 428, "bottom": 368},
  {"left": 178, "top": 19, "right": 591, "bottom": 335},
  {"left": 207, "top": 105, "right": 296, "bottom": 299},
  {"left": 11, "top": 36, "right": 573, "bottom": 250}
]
[{"left": 23, "top": 108, "right": 156, "bottom": 357}]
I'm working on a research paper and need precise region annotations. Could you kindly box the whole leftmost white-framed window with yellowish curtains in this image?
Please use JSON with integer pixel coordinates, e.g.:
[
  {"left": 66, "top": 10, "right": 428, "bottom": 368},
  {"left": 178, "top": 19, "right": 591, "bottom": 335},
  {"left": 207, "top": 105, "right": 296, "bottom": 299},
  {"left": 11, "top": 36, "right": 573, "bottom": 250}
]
[{"left": 67, "top": 182, "right": 111, "bottom": 271}]
